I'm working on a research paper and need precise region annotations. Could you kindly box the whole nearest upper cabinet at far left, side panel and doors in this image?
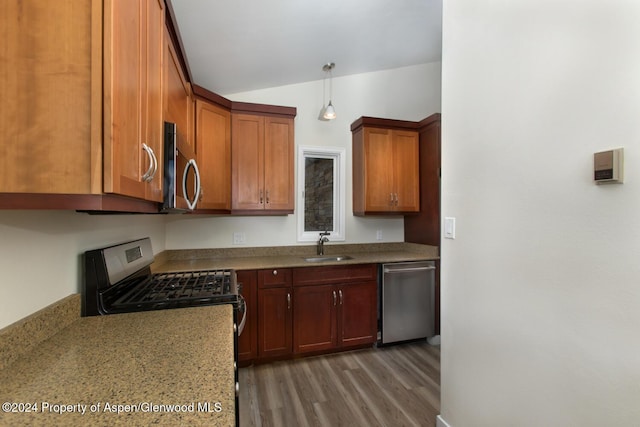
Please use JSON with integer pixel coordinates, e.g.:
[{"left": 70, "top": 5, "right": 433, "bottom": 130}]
[{"left": 0, "top": 0, "right": 165, "bottom": 212}]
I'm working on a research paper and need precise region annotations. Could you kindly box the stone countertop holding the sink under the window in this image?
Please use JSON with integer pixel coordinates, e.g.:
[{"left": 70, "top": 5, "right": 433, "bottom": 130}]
[{"left": 152, "top": 243, "right": 439, "bottom": 272}]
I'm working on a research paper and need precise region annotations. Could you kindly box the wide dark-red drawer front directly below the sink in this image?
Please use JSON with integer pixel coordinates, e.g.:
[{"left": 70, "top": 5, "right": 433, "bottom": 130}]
[{"left": 293, "top": 264, "right": 378, "bottom": 286}]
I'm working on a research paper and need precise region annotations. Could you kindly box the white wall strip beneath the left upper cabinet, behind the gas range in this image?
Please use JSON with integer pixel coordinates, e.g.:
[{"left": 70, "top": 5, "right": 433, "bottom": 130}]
[{"left": 0, "top": 211, "right": 165, "bottom": 329}]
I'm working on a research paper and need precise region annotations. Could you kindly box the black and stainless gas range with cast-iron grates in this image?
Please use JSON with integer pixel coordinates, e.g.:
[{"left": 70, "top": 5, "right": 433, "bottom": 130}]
[{"left": 82, "top": 237, "right": 247, "bottom": 420}]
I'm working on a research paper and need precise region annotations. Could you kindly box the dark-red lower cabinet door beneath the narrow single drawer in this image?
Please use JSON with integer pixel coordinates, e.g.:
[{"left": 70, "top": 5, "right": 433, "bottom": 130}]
[{"left": 258, "top": 287, "right": 292, "bottom": 357}]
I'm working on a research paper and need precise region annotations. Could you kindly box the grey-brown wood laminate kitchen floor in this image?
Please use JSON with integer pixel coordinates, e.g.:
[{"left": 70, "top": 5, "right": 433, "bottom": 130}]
[{"left": 239, "top": 341, "right": 440, "bottom": 427}]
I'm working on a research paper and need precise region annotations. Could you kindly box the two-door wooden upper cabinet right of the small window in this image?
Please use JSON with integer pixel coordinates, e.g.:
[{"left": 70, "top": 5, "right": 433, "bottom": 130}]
[{"left": 351, "top": 117, "right": 420, "bottom": 215}]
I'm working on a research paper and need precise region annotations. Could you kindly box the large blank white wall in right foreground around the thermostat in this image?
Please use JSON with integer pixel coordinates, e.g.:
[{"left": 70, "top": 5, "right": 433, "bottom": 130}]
[{"left": 441, "top": 0, "right": 640, "bottom": 427}]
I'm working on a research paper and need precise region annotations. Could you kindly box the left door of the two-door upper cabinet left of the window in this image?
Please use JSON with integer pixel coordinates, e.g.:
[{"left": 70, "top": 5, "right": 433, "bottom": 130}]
[{"left": 231, "top": 114, "right": 265, "bottom": 210}]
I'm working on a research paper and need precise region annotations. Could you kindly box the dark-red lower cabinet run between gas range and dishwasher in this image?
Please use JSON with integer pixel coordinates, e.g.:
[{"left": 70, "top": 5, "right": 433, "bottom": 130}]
[{"left": 246, "top": 264, "right": 378, "bottom": 364}]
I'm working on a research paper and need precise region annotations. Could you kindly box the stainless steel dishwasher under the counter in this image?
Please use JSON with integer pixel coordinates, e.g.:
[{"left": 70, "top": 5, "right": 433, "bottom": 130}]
[{"left": 380, "top": 261, "right": 436, "bottom": 344}]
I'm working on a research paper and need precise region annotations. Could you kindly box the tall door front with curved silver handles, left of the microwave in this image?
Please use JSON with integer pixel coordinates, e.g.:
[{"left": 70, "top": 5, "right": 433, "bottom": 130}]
[{"left": 104, "top": 0, "right": 165, "bottom": 202}]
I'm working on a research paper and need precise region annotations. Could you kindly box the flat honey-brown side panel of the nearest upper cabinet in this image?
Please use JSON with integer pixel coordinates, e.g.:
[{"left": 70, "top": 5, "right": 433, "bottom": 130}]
[{"left": 0, "top": 0, "right": 95, "bottom": 194}]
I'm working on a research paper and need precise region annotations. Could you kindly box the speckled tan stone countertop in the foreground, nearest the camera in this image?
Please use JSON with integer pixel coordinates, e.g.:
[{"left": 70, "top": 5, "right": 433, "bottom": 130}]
[{"left": 0, "top": 305, "right": 235, "bottom": 426}]
